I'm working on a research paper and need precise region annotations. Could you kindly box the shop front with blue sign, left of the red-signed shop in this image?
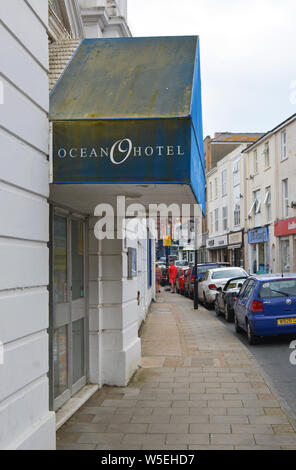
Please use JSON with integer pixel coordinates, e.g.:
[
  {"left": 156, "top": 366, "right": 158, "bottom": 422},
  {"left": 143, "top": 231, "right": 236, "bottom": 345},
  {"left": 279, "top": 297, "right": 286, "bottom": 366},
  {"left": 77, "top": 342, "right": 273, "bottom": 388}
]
[{"left": 248, "top": 226, "right": 271, "bottom": 274}]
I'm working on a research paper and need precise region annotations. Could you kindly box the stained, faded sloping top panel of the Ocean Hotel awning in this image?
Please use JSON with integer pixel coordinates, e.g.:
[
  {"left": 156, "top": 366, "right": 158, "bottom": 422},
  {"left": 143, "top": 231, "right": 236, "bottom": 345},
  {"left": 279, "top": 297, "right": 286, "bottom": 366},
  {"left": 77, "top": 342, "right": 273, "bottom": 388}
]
[{"left": 50, "top": 36, "right": 198, "bottom": 121}]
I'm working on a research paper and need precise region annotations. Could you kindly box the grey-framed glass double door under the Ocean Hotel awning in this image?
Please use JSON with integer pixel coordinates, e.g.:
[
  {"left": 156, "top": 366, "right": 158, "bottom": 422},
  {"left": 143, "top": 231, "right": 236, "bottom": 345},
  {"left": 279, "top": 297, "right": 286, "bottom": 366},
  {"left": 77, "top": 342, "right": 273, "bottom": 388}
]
[{"left": 50, "top": 211, "right": 87, "bottom": 410}]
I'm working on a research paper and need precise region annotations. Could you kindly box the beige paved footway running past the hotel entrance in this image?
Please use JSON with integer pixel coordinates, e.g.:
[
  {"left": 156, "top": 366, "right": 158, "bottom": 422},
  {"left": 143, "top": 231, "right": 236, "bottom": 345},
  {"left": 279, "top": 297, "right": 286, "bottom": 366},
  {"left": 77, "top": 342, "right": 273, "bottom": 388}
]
[{"left": 57, "top": 292, "right": 296, "bottom": 450}]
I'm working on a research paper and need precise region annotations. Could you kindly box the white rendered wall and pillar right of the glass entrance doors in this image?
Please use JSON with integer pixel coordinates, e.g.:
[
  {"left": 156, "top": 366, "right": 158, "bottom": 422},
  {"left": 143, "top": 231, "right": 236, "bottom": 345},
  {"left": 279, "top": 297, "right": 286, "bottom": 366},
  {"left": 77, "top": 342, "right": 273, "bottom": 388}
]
[{"left": 89, "top": 218, "right": 155, "bottom": 386}]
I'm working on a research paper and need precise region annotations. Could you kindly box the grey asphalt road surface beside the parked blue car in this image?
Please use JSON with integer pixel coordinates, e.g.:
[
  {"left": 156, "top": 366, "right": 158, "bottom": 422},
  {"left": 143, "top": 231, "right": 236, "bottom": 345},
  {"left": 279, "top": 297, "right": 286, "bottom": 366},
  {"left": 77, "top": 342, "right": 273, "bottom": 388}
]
[{"left": 207, "top": 310, "right": 296, "bottom": 416}]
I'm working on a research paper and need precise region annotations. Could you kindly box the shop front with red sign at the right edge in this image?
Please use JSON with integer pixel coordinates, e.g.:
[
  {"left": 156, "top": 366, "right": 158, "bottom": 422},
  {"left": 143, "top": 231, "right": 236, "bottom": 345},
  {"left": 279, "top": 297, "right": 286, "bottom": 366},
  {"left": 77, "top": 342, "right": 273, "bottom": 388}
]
[{"left": 274, "top": 217, "right": 296, "bottom": 273}]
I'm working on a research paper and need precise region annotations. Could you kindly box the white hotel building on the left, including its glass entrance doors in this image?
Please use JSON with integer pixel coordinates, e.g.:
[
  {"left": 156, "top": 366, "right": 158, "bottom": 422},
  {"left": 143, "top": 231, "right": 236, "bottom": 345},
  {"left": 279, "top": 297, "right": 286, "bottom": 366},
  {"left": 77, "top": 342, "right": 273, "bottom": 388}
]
[{"left": 0, "top": 0, "right": 155, "bottom": 449}]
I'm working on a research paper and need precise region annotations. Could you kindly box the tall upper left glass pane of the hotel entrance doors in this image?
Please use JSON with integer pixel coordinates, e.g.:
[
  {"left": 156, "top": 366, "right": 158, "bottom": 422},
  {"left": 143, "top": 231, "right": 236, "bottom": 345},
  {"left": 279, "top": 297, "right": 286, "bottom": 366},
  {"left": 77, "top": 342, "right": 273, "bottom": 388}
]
[{"left": 53, "top": 215, "right": 67, "bottom": 303}]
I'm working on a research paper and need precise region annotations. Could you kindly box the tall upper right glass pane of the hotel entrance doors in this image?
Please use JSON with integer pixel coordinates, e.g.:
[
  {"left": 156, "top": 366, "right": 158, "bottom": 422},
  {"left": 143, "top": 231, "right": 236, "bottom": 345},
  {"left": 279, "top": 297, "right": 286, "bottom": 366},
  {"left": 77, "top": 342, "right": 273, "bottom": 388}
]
[{"left": 71, "top": 220, "right": 84, "bottom": 300}]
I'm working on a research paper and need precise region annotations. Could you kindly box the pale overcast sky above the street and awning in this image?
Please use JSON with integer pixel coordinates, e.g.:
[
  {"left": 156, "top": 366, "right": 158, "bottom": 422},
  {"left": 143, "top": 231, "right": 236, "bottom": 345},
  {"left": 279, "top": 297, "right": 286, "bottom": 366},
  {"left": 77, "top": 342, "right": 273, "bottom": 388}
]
[{"left": 128, "top": 0, "right": 296, "bottom": 135}]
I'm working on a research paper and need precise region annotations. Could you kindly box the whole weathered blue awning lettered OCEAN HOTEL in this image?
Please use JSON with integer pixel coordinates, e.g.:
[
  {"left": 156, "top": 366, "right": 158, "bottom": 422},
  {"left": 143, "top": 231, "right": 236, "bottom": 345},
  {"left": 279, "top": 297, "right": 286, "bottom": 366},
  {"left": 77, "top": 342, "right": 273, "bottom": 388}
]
[{"left": 50, "top": 36, "right": 205, "bottom": 212}]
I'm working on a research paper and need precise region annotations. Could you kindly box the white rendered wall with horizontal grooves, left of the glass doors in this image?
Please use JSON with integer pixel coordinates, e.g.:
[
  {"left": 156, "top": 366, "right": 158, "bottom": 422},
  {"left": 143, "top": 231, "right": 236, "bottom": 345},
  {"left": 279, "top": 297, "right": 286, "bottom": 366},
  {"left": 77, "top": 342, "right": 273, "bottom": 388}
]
[{"left": 0, "top": 0, "right": 55, "bottom": 449}]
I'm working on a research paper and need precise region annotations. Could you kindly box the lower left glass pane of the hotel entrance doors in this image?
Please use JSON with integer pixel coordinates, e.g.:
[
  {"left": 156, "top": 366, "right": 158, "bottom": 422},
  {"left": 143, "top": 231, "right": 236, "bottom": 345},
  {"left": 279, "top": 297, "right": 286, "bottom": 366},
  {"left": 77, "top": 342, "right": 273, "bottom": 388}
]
[{"left": 53, "top": 326, "right": 68, "bottom": 398}]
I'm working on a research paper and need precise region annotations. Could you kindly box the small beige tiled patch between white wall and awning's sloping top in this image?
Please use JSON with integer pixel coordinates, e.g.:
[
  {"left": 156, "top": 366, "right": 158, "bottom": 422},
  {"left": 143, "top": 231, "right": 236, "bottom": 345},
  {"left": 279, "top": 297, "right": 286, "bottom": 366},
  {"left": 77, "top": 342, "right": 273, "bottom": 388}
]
[{"left": 49, "top": 39, "right": 81, "bottom": 91}]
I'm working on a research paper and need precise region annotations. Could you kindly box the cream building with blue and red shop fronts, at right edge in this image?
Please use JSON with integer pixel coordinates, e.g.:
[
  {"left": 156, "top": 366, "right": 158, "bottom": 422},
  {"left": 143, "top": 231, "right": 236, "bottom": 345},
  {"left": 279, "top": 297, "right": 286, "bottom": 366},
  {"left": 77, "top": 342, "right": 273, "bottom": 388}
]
[{"left": 245, "top": 115, "right": 296, "bottom": 273}]
